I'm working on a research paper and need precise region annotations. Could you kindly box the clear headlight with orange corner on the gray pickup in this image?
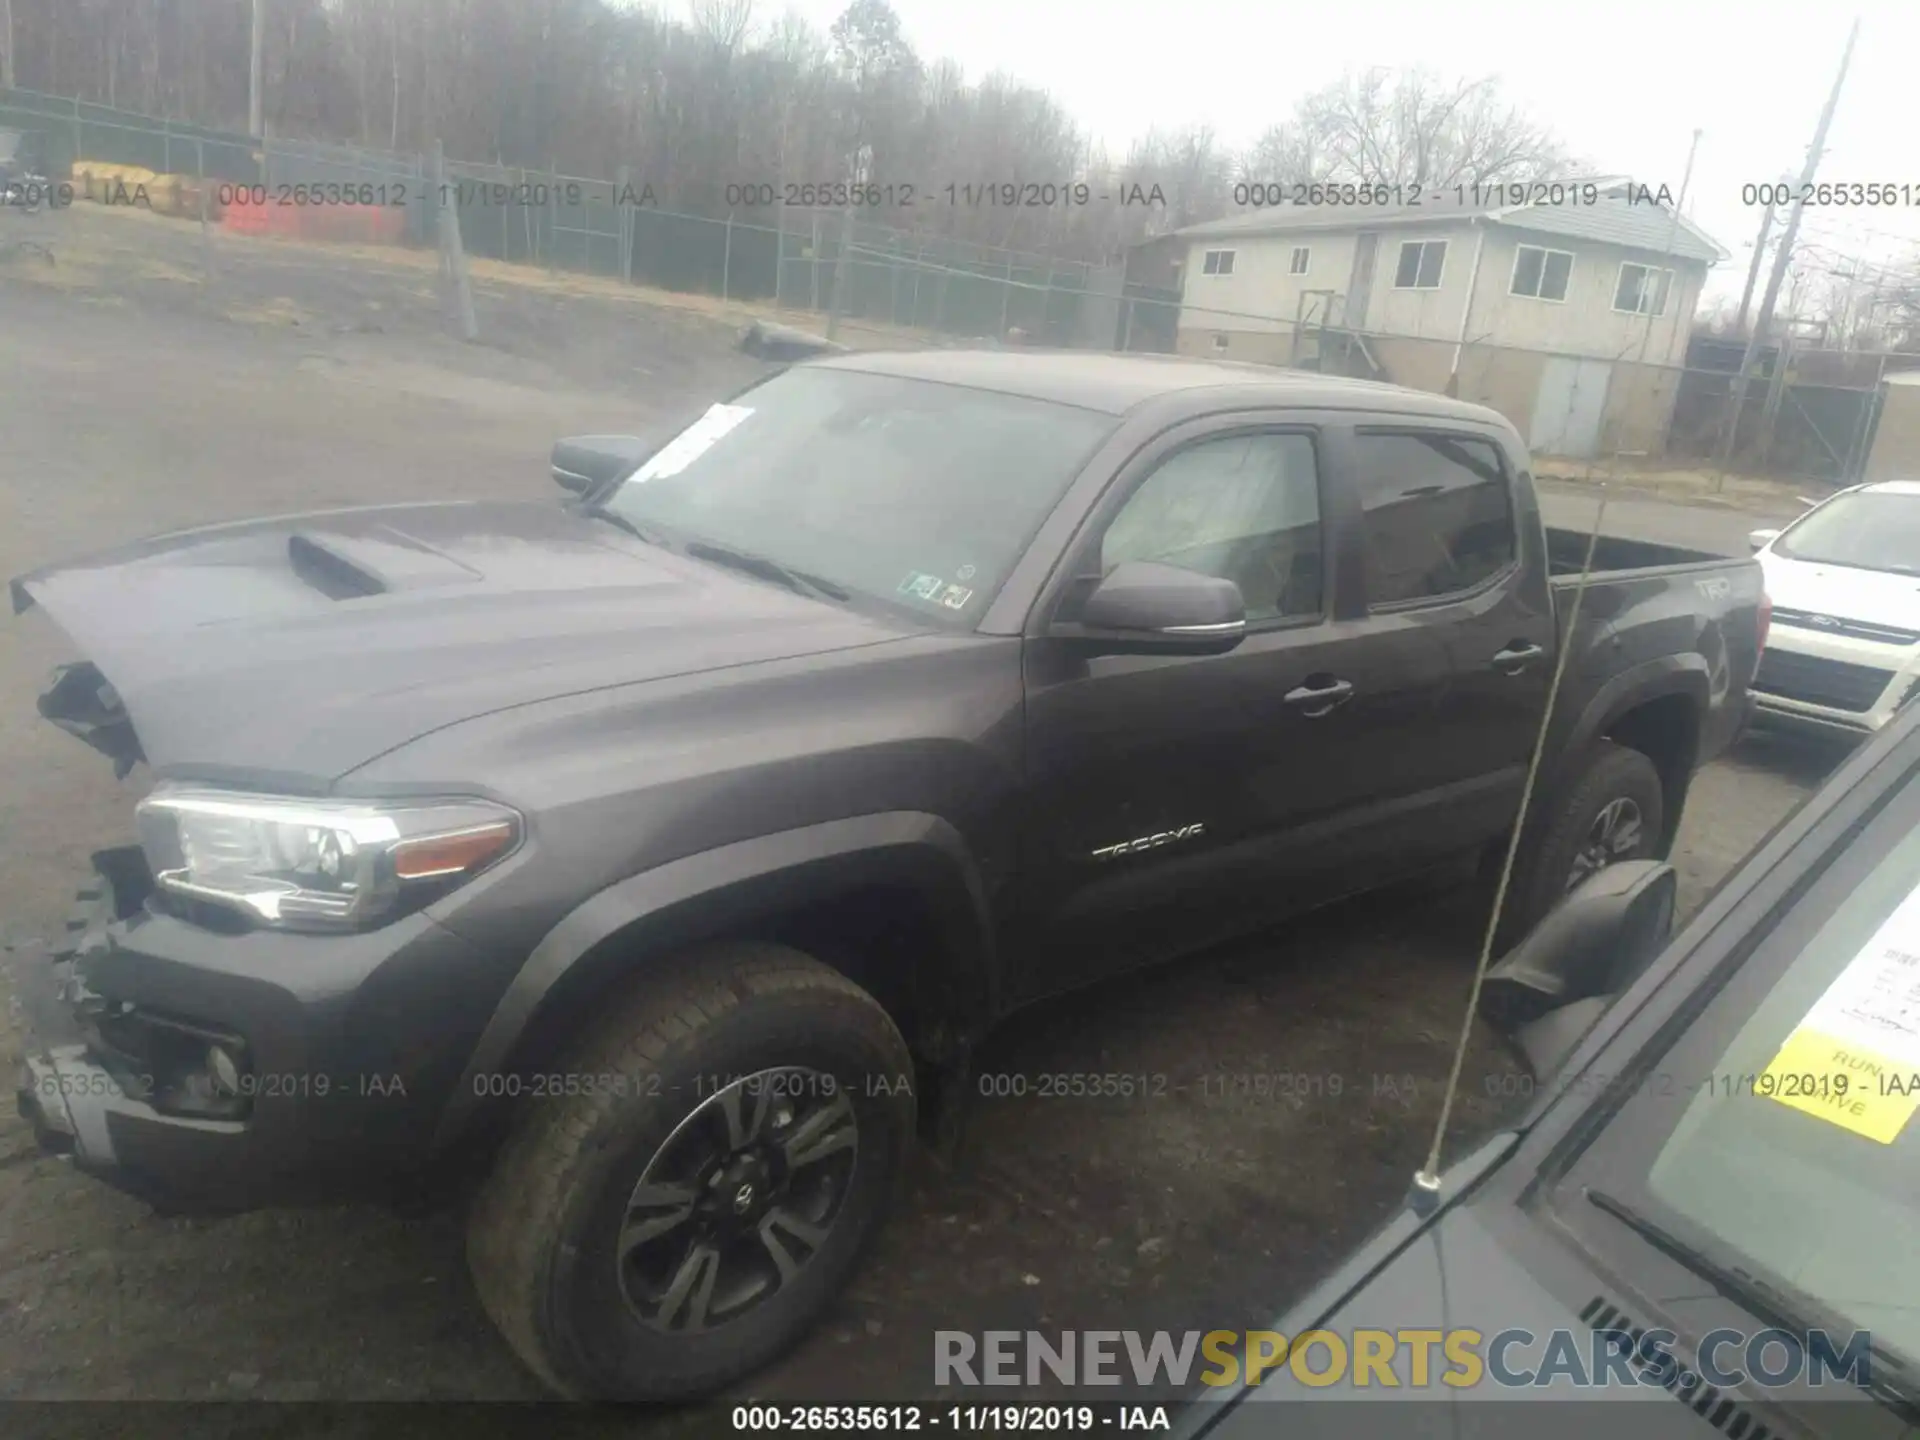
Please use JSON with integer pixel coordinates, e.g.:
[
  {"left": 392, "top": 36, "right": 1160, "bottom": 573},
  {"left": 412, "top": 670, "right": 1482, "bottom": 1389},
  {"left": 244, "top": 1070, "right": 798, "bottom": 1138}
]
[{"left": 138, "top": 785, "right": 520, "bottom": 929}]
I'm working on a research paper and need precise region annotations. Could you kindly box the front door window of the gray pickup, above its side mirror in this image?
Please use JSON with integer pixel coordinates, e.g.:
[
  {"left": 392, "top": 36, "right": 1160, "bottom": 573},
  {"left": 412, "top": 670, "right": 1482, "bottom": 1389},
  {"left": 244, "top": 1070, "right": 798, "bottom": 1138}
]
[{"left": 1100, "top": 434, "right": 1321, "bottom": 620}]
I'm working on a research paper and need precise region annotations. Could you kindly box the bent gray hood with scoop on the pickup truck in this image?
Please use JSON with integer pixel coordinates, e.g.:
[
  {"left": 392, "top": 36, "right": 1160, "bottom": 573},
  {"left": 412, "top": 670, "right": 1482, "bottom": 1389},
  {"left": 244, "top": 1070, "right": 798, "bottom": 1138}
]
[{"left": 12, "top": 501, "right": 900, "bottom": 789}]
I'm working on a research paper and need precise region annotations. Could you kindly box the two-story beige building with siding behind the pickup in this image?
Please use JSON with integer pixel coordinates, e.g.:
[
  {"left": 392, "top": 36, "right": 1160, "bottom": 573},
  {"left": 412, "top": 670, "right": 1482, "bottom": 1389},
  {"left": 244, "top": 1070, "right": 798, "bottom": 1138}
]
[{"left": 1177, "top": 177, "right": 1728, "bottom": 457}]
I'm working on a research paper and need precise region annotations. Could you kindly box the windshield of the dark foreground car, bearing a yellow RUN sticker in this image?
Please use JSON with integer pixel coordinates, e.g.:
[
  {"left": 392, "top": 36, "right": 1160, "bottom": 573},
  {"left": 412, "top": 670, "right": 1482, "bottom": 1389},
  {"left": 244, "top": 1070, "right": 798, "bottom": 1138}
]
[{"left": 1574, "top": 760, "right": 1920, "bottom": 1357}]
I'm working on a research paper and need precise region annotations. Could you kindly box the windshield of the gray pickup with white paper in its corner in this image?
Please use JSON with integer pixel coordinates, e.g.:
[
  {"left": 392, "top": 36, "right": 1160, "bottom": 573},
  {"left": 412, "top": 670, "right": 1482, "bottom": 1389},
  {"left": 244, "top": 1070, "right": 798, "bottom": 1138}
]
[{"left": 607, "top": 367, "right": 1116, "bottom": 624}]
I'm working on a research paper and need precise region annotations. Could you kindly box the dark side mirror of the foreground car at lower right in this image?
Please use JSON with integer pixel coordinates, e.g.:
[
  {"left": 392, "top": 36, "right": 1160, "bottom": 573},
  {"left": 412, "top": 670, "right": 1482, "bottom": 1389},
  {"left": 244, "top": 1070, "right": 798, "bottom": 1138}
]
[{"left": 1480, "top": 860, "right": 1678, "bottom": 1077}]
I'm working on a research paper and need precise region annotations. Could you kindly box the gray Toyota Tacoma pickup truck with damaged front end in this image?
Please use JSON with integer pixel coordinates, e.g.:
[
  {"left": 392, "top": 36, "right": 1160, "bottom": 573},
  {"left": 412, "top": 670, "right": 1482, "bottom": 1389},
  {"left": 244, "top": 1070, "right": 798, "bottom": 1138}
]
[{"left": 12, "top": 351, "right": 1764, "bottom": 1398}]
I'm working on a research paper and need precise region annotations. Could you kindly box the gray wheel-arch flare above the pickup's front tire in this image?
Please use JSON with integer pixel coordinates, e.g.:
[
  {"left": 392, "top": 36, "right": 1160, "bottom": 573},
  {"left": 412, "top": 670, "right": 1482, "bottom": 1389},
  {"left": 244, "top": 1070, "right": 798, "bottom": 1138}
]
[{"left": 434, "top": 810, "right": 1000, "bottom": 1152}]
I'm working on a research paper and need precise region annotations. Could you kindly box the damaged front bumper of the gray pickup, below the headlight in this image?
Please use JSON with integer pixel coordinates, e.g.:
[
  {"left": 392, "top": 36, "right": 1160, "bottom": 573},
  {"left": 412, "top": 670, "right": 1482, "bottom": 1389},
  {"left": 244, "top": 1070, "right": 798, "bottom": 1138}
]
[{"left": 6, "top": 851, "right": 497, "bottom": 1213}]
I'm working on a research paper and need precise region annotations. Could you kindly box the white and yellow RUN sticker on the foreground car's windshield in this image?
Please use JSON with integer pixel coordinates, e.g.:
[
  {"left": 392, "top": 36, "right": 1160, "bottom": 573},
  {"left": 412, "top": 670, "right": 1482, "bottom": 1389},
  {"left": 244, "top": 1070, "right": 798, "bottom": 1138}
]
[{"left": 1753, "top": 891, "right": 1920, "bottom": 1144}]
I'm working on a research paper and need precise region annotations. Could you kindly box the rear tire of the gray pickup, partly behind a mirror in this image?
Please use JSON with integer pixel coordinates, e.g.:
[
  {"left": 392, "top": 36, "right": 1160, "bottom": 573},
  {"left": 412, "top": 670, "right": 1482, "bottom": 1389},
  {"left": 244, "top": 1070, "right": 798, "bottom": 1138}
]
[{"left": 1498, "top": 739, "right": 1667, "bottom": 950}]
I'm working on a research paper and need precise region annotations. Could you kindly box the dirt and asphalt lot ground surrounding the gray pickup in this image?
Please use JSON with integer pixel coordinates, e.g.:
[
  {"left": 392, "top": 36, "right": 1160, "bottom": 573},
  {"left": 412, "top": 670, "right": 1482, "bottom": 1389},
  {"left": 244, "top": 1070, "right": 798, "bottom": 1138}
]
[{"left": 0, "top": 208, "right": 1830, "bottom": 1436}]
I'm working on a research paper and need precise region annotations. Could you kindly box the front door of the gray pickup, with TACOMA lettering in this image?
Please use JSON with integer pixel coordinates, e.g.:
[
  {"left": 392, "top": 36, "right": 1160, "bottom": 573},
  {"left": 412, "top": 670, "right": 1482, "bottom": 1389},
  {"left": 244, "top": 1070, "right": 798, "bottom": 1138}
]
[{"left": 1010, "top": 420, "right": 1450, "bottom": 998}]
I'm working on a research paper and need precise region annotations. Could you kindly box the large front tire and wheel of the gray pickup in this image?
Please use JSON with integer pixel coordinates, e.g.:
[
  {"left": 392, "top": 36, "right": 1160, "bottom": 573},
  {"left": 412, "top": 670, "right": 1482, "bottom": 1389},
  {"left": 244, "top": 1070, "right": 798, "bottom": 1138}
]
[{"left": 467, "top": 943, "right": 914, "bottom": 1402}]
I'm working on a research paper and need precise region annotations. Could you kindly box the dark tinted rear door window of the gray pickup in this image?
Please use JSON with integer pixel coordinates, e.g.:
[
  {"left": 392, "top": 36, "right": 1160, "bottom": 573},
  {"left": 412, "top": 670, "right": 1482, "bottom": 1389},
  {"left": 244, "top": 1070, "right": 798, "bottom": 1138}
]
[{"left": 1354, "top": 434, "right": 1515, "bottom": 605}]
